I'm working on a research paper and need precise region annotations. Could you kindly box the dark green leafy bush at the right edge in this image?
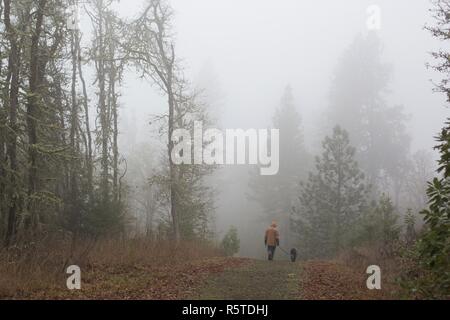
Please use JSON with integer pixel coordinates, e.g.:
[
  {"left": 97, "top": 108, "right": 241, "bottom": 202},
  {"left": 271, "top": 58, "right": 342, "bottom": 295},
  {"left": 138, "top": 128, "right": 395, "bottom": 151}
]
[{"left": 404, "top": 119, "right": 450, "bottom": 299}]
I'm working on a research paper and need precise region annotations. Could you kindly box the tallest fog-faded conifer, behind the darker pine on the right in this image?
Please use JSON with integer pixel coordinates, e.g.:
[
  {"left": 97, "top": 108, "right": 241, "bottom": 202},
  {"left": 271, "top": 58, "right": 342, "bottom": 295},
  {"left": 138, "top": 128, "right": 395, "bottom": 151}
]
[{"left": 328, "top": 32, "right": 409, "bottom": 195}]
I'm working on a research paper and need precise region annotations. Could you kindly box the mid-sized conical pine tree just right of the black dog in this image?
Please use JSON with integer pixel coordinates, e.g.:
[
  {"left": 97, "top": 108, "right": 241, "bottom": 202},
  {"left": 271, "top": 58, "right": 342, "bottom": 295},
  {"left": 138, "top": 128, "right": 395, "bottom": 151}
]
[{"left": 294, "top": 126, "right": 369, "bottom": 257}]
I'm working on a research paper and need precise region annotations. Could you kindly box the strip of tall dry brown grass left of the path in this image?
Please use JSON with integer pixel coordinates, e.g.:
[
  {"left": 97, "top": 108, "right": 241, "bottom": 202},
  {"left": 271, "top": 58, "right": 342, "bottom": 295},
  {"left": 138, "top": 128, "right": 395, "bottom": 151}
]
[{"left": 0, "top": 238, "right": 221, "bottom": 299}]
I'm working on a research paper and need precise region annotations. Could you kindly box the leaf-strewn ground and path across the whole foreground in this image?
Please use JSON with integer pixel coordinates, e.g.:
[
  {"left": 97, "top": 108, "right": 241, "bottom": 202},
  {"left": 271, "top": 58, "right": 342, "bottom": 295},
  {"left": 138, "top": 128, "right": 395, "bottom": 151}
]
[{"left": 7, "top": 258, "right": 396, "bottom": 300}]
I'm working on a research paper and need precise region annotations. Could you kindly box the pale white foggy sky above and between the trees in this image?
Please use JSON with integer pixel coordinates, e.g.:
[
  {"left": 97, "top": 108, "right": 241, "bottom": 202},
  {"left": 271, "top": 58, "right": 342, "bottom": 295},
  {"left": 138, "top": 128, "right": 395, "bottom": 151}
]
[{"left": 103, "top": 0, "right": 450, "bottom": 155}]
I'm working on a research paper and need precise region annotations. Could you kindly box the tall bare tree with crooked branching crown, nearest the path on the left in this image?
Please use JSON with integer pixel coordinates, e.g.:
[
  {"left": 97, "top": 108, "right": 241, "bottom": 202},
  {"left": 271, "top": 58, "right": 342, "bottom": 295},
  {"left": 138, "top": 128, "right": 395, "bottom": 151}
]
[{"left": 125, "top": 0, "right": 182, "bottom": 240}]
